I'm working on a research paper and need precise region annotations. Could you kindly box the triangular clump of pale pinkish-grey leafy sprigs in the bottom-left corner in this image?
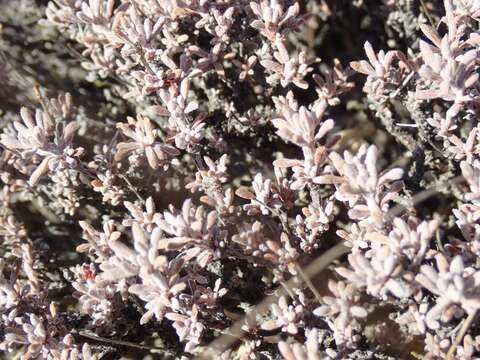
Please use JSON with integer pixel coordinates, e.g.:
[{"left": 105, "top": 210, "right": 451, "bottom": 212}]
[{"left": 0, "top": 239, "right": 102, "bottom": 360}]
